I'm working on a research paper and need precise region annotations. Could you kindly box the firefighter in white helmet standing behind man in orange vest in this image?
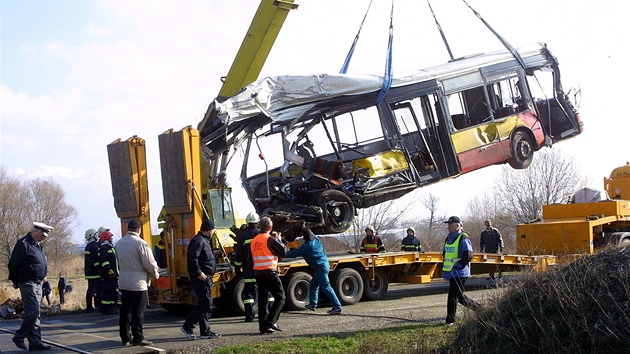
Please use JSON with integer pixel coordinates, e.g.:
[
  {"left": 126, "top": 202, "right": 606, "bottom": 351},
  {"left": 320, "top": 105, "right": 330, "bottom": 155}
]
[{"left": 234, "top": 212, "right": 260, "bottom": 322}]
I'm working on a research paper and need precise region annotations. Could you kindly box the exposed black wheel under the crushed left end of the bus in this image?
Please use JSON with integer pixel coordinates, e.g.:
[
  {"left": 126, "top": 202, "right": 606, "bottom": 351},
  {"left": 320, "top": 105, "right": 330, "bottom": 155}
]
[{"left": 310, "top": 189, "right": 354, "bottom": 234}]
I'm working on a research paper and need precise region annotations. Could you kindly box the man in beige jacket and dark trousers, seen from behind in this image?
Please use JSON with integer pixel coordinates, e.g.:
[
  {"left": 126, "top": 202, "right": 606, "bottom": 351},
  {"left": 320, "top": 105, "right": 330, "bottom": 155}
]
[{"left": 114, "top": 220, "right": 160, "bottom": 346}]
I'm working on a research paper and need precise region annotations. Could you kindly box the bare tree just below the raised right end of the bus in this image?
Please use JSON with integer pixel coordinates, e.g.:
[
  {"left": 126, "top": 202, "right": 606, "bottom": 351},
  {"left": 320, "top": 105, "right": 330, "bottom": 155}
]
[{"left": 495, "top": 149, "right": 587, "bottom": 228}]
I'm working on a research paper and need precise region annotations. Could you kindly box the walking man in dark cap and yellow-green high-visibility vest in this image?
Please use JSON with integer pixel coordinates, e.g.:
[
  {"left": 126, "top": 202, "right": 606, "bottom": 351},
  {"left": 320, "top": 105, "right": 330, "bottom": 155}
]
[{"left": 442, "top": 216, "right": 481, "bottom": 326}]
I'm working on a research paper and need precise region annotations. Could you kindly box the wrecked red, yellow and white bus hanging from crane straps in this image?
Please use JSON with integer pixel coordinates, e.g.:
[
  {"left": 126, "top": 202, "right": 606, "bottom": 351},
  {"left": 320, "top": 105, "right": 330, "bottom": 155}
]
[{"left": 199, "top": 43, "right": 583, "bottom": 234}]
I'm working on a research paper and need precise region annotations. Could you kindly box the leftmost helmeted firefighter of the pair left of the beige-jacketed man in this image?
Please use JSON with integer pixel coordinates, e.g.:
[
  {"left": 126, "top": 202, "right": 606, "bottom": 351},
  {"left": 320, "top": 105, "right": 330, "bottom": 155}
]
[{"left": 84, "top": 229, "right": 101, "bottom": 313}]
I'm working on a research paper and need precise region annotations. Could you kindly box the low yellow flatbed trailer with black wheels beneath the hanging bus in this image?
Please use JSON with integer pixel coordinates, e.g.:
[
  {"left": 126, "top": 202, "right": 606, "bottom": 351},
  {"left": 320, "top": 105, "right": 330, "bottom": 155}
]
[{"left": 194, "top": 252, "right": 557, "bottom": 314}]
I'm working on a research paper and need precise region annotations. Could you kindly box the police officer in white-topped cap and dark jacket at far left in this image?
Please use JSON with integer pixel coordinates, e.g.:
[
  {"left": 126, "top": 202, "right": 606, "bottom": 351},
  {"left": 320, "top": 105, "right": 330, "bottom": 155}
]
[{"left": 8, "top": 222, "right": 53, "bottom": 351}]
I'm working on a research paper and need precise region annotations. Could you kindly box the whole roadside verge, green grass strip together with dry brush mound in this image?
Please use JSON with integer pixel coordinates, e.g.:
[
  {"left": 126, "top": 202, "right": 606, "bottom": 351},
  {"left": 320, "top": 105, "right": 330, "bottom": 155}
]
[{"left": 209, "top": 248, "right": 630, "bottom": 354}]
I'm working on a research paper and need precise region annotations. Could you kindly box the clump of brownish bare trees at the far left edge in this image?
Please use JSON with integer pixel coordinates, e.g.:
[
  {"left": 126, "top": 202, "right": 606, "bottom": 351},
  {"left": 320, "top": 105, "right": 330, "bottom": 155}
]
[{"left": 0, "top": 167, "right": 77, "bottom": 272}]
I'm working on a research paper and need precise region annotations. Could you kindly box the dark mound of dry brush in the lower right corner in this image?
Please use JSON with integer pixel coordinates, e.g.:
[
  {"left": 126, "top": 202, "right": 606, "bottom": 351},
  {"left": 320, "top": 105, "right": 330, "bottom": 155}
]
[{"left": 444, "top": 248, "right": 630, "bottom": 353}]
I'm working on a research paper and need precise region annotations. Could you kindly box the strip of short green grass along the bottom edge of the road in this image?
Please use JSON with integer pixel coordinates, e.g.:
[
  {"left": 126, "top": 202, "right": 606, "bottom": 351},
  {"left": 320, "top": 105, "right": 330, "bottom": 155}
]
[{"left": 213, "top": 323, "right": 454, "bottom": 354}]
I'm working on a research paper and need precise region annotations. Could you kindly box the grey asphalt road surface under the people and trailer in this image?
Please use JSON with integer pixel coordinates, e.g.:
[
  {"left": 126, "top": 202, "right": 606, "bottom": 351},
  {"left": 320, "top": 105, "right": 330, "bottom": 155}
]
[{"left": 0, "top": 277, "right": 500, "bottom": 353}]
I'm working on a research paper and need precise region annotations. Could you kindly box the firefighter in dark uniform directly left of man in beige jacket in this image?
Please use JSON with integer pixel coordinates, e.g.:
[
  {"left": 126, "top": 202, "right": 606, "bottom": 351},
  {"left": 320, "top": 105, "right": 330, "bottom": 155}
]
[{"left": 99, "top": 231, "right": 118, "bottom": 315}]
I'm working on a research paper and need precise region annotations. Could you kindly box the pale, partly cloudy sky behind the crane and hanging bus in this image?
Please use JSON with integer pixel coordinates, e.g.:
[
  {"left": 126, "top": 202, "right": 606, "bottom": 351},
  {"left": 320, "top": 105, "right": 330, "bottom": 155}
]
[{"left": 0, "top": 0, "right": 630, "bottom": 244}]
